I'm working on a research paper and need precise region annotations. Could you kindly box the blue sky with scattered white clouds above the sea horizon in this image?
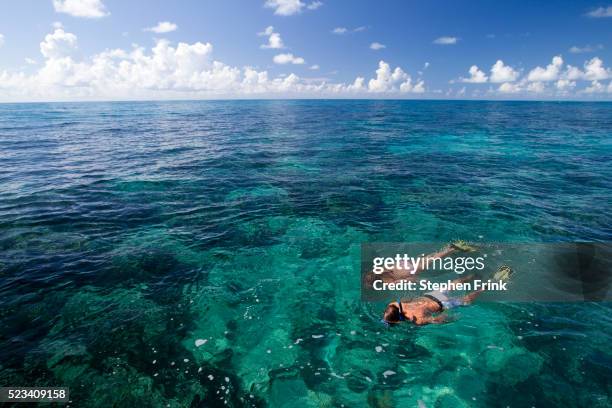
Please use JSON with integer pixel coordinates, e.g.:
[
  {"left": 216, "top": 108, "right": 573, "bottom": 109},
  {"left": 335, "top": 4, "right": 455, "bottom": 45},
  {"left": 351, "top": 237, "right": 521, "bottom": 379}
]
[{"left": 0, "top": 0, "right": 612, "bottom": 101}]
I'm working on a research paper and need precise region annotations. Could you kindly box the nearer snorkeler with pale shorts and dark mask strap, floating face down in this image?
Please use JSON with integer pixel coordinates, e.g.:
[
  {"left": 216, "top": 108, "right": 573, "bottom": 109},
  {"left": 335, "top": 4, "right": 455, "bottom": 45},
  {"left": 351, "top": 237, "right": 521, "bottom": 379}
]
[{"left": 382, "top": 265, "right": 512, "bottom": 326}]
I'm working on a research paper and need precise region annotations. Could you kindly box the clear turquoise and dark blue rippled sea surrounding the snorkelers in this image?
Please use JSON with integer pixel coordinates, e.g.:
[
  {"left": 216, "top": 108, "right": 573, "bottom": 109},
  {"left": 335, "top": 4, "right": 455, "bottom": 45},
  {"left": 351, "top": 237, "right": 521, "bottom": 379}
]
[{"left": 0, "top": 101, "right": 612, "bottom": 408}]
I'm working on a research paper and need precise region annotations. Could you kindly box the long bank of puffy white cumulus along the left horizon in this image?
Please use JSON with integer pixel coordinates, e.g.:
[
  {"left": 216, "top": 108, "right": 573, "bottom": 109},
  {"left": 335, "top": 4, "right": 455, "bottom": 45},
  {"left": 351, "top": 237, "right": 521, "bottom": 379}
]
[{"left": 0, "top": 28, "right": 425, "bottom": 101}]
